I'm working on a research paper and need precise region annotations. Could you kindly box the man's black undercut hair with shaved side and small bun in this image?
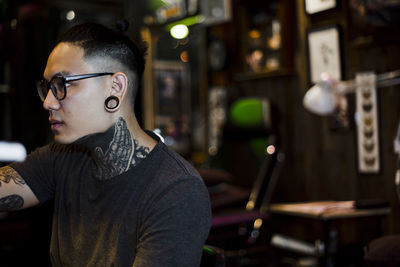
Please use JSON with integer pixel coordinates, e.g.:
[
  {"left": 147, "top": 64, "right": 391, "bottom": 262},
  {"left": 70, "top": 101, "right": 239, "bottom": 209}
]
[{"left": 57, "top": 23, "right": 146, "bottom": 110}]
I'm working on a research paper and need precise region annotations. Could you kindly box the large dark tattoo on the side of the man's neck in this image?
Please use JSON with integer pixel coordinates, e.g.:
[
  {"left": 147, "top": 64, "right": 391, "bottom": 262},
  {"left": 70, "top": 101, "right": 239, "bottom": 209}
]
[{"left": 95, "top": 118, "right": 150, "bottom": 180}]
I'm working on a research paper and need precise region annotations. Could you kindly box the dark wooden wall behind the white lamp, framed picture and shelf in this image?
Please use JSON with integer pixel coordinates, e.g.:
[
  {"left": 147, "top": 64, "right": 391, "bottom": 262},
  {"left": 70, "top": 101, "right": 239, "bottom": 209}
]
[{"left": 208, "top": 0, "right": 400, "bottom": 233}]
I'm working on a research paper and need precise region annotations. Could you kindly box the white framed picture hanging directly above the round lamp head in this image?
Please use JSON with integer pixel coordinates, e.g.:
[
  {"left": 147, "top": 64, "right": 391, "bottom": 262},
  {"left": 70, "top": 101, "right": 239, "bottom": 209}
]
[{"left": 307, "top": 26, "right": 342, "bottom": 83}]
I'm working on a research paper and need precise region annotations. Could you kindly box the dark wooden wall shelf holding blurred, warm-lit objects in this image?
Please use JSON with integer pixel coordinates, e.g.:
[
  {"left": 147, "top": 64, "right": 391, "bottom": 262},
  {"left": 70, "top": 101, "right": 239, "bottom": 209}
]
[{"left": 234, "top": 0, "right": 294, "bottom": 78}]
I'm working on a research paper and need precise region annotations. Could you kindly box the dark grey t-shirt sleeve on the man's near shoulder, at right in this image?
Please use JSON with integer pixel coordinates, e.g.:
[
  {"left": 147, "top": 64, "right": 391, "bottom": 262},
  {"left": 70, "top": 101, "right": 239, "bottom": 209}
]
[{"left": 133, "top": 177, "right": 211, "bottom": 267}]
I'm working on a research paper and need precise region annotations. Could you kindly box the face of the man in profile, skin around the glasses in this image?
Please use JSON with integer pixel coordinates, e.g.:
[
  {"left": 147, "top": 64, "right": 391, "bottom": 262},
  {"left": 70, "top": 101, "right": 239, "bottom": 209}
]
[{"left": 43, "top": 43, "right": 112, "bottom": 144}]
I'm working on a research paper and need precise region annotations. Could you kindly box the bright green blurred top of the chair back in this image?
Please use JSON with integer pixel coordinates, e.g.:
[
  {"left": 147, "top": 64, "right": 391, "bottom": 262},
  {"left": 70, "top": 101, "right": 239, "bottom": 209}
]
[{"left": 229, "top": 98, "right": 264, "bottom": 127}]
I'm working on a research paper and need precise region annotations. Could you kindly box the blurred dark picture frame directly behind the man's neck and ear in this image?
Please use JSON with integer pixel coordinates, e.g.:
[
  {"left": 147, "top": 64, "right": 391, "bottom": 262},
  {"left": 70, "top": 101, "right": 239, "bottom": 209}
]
[{"left": 153, "top": 61, "right": 191, "bottom": 153}]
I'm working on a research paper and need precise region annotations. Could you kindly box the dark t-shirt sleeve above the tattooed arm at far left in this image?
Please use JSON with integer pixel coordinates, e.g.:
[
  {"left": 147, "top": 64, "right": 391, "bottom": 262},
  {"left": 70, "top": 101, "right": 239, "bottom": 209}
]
[{"left": 10, "top": 145, "right": 55, "bottom": 203}]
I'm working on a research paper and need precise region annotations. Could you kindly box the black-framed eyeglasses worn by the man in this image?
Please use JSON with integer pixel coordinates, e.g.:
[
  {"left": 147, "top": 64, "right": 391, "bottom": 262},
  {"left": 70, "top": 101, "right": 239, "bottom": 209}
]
[{"left": 36, "top": 72, "right": 114, "bottom": 101}]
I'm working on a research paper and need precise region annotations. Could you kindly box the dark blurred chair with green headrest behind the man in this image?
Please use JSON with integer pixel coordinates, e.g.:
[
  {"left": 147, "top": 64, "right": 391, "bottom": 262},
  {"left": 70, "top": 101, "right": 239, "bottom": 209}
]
[{"left": 200, "top": 98, "right": 285, "bottom": 254}]
